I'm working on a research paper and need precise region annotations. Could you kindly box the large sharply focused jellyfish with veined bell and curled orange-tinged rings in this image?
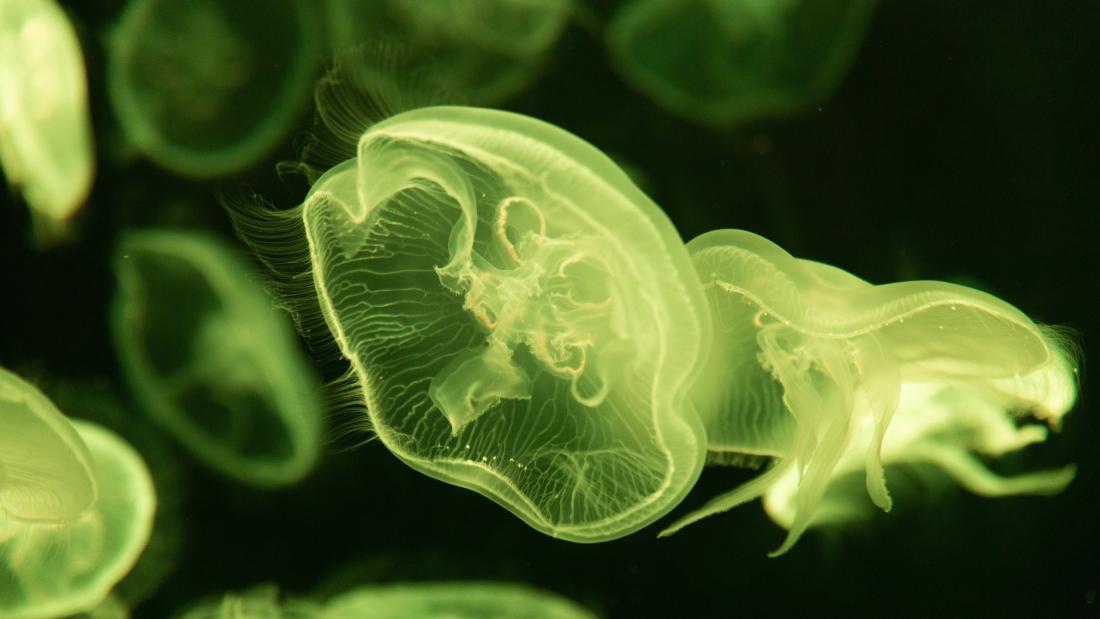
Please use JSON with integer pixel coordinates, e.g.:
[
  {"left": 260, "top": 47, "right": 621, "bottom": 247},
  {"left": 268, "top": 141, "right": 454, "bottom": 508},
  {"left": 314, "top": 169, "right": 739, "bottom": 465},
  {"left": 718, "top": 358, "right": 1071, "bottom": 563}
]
[{"left": 301, "top": 108, "right": 710, "bottom": 542}]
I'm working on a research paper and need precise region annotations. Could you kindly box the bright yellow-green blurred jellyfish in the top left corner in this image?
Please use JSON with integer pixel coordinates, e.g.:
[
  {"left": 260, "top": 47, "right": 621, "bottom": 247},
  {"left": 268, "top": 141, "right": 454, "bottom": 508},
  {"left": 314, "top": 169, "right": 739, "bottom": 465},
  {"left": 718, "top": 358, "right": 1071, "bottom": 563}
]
[{"left": 0, "top": 0, "right": 95, "bottom": 233}]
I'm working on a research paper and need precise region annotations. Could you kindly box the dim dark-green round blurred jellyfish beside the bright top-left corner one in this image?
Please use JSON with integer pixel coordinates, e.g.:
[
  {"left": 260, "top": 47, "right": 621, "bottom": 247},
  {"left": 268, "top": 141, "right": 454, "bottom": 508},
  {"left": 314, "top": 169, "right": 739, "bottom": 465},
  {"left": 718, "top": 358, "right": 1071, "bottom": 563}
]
[{"left": 107, "top": 0, "right": 320, "bottom": 177}]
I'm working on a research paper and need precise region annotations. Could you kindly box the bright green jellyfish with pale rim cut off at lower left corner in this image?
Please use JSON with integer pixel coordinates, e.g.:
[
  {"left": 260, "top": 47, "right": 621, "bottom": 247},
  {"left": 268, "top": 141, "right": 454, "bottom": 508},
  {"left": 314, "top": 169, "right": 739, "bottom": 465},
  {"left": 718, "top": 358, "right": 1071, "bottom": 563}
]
[{"left": 0, "top": 369, "right": 156, "bottom": 617}]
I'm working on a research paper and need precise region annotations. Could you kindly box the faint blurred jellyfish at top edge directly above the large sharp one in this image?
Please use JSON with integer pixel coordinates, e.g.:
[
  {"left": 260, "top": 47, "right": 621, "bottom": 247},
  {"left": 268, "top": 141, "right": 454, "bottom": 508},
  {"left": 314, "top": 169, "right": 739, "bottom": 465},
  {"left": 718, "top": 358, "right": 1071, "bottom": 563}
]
[{"left": 329, "top": 0, "right": 573, "bottom": 106}]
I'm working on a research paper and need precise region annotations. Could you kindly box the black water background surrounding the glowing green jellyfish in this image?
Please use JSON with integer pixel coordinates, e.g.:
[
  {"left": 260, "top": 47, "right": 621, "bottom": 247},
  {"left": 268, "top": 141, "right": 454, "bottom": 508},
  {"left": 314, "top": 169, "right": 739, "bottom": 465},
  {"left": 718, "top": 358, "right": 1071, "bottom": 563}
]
[{"left": 0, "top": 1, "right": 1100, "bottom": 617}]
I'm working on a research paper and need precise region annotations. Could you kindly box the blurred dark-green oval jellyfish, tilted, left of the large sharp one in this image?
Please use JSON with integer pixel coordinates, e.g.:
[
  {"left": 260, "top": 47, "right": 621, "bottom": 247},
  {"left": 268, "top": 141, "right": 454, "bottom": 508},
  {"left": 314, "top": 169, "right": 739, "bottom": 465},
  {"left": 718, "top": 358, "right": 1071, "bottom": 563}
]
[{"left": 112, "top": 230, "right": 322, "bottom": 486}]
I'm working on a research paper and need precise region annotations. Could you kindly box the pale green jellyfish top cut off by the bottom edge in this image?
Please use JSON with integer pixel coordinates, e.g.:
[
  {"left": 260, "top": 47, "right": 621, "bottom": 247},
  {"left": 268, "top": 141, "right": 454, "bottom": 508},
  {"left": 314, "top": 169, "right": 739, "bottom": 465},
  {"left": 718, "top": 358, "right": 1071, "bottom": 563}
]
[{"left": 325, "top": 582, "right": 595, "bottom": 619}]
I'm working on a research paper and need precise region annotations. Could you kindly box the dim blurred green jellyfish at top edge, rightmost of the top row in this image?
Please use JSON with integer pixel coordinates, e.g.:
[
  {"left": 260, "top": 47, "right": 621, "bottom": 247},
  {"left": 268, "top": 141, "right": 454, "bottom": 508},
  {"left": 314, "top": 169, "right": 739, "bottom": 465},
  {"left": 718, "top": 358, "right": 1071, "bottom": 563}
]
[{"left": 607, "top": 0, "right": 875, "bottom": 125}]
